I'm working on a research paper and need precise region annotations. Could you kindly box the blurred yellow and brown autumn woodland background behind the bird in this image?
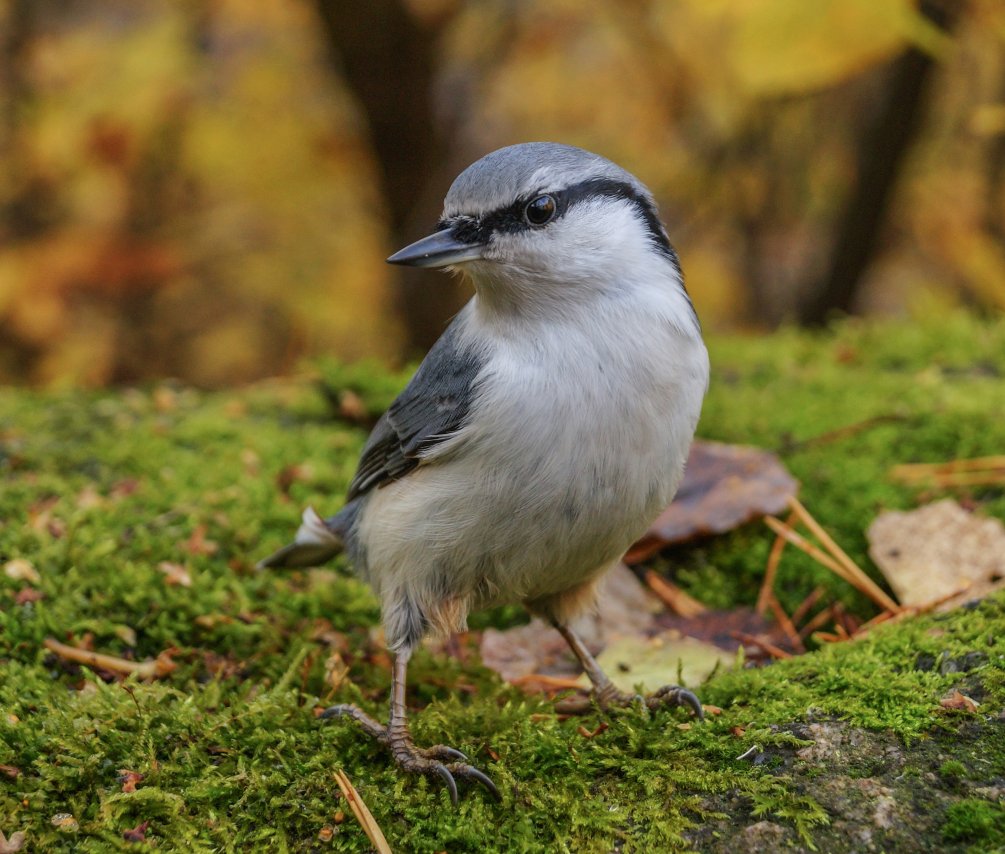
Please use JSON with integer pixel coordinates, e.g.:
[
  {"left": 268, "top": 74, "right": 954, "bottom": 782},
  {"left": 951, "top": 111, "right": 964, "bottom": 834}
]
[{"left": 0, "top": 0, "right": 1005, "bottom": 387}]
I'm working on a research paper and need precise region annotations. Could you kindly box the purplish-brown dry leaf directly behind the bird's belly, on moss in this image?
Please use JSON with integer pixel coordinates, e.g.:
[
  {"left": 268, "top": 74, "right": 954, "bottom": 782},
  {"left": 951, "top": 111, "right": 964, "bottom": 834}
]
[{"left": 625, "top": 442, "right": 798, "bottom": 564}]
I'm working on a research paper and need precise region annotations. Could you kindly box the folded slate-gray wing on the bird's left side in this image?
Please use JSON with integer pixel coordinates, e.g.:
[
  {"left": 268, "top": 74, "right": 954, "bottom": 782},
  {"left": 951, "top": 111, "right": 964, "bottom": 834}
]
[{"left": 348, "top": 315, "right": 484, "bottom": 501}]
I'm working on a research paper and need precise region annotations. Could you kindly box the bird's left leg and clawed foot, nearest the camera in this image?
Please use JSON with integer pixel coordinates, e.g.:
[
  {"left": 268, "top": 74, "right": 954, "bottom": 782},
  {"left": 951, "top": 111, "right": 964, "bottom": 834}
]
[{"left": 321, "top": 649, "right": 500, "bottom": 805}]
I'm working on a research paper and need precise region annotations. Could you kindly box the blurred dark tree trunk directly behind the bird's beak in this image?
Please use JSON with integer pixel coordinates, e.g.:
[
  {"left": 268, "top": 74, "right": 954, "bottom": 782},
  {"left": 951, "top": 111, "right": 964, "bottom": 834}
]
[{"left": 317, "top": 0, "right": 462, "bottom": 356}]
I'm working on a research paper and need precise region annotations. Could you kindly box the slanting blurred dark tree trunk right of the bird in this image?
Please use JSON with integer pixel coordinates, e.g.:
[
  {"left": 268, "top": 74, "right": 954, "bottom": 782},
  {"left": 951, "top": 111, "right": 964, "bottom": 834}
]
[{"left": 799, "top": 0, "right": 964, "bottom": 326}]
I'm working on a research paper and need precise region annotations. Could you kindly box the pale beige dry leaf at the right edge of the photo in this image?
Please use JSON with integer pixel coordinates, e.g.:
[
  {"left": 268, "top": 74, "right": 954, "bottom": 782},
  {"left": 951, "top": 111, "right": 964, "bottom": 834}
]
[{"left": 867, "top": 499, "right": 1005, "bottom": 611}]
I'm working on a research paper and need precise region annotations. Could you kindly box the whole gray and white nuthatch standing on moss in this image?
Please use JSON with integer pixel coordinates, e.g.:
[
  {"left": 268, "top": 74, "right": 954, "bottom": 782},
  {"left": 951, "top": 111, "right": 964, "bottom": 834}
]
[{"left": 262, "top": 143, "right": 709, "bottom": 803}]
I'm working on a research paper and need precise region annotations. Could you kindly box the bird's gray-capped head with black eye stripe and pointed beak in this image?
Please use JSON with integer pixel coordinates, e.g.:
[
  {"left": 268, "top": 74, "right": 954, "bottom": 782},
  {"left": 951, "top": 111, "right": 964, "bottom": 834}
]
[{"left": 388, "top": 143, "right": 682, "bottom": 310}]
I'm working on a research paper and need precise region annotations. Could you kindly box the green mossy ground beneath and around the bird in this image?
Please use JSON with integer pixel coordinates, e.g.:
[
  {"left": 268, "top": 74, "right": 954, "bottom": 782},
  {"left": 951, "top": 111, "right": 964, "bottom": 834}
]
[{"left": 0, "top": 315, "right": 1005, "bottom": 852}]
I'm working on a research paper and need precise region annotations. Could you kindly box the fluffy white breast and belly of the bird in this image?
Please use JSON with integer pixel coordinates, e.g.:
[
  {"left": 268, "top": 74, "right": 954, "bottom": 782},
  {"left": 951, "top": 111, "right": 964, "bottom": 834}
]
[{"left": 359, "top": 285, "right": 709, "bottom": 614}]
